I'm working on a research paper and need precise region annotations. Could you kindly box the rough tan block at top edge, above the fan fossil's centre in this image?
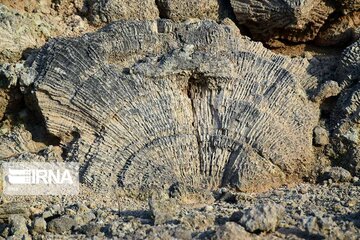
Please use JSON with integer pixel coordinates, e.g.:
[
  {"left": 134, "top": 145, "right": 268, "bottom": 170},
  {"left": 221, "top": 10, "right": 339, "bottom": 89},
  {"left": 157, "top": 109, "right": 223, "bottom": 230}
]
[{"left": 158, "top": 0, "right": 220, "bottom": 21}]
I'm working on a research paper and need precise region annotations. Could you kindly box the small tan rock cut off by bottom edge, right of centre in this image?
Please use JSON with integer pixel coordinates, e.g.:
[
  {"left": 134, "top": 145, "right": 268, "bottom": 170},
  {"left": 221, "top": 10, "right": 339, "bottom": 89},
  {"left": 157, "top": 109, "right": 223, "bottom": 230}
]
[{"left": 216, "top": 222, "right": 251, "bottom": 240}]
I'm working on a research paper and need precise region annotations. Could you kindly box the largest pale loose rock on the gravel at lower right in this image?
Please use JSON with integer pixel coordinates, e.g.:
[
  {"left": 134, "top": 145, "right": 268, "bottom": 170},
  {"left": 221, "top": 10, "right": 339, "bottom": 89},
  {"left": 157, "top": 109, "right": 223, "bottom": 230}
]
[{"left": 239, "top": 203, "right": 285, "bottom": 232}]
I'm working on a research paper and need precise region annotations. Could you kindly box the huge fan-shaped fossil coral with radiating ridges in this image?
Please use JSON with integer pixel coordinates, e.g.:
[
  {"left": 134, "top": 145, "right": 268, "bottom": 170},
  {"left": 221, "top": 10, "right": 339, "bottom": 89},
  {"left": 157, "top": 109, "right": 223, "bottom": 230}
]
[{"left": 28, "top": 20, "right": 318, "bottom": 191}]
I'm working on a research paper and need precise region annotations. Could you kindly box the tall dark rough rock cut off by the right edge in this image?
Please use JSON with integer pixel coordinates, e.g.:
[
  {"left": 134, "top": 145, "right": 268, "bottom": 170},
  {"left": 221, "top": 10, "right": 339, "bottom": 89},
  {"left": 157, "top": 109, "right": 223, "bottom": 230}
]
[{"left": 331, "top": 40, "right": 360, "bottom": 176}]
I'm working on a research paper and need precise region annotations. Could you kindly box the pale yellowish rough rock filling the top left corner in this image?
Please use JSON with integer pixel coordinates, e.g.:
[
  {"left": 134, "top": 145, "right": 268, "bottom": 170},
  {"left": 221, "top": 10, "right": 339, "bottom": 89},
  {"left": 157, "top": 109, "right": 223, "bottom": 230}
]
[{"left": 0, "top": 1, "right": 92, "bottom": 63}]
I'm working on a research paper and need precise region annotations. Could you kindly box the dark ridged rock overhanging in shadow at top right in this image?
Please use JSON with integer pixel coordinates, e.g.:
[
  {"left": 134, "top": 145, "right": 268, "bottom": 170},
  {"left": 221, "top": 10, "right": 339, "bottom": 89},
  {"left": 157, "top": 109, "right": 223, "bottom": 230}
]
[{"left": 231, "top": 0, "right": 334, "bottom": 42}]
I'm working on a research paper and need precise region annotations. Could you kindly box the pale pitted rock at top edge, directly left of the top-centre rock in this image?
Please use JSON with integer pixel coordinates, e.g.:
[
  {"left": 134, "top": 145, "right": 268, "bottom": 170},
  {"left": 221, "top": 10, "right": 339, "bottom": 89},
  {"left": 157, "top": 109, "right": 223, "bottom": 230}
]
[{"left": 85, "top": 0, "right": 160, "bottom": 24}]
